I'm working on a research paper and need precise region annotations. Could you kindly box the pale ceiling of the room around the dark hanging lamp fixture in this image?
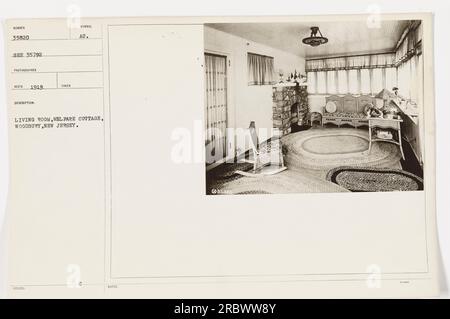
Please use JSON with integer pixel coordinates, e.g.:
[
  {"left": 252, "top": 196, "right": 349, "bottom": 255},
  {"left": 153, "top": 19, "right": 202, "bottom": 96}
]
[{"left": 208, "top": 20, "right": 408, "bottom": 58}]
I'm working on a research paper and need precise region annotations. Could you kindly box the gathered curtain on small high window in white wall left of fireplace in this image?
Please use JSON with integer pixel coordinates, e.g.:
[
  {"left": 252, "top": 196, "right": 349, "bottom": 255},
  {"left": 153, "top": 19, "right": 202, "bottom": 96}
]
[{"left": 247, "top": 53, "right": 275, "bottom": 85}]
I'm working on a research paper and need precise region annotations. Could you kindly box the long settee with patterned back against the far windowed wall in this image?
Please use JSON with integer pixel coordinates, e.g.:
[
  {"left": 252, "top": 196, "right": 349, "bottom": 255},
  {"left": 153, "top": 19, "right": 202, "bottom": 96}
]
[{"left": 322, "top": 94, "right": 383, "bottom": 128}]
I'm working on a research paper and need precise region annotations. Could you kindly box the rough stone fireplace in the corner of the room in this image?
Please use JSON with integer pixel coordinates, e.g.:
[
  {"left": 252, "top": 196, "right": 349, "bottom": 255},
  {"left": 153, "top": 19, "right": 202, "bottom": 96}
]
[{"left": 272, "top": 84, "right": 308, "bottom": 135}]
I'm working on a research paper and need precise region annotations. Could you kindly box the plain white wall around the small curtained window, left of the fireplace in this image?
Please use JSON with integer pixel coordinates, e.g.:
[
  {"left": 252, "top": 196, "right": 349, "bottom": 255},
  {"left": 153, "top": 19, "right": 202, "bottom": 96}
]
[{"left": 205, "top": 27, "right": 305, "bottom": 151}]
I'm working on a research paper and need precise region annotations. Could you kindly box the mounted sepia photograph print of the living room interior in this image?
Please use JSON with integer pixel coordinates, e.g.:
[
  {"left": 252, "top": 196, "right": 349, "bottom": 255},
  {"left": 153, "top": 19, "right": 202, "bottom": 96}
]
[{"left": 204, "top": 17, "right": 425, "bottom": 195}]
